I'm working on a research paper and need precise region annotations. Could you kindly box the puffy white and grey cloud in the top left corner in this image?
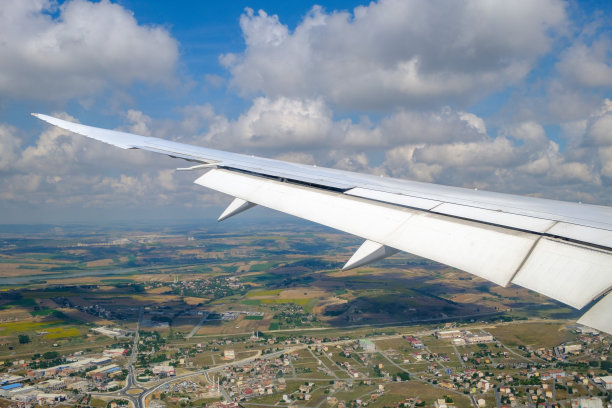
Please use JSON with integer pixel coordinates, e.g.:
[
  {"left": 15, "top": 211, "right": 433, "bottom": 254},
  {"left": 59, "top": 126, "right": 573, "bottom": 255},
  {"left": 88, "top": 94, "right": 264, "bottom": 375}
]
[{"left": 0, "top": 0, "right": 178, "bottom": 101}]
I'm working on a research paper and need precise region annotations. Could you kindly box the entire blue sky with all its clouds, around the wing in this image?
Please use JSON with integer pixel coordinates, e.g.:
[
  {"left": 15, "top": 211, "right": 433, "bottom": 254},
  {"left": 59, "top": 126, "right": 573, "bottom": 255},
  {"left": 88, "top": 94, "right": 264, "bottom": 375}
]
[{"left": 0, "top": 0, "right": 612, "bottom": 223}]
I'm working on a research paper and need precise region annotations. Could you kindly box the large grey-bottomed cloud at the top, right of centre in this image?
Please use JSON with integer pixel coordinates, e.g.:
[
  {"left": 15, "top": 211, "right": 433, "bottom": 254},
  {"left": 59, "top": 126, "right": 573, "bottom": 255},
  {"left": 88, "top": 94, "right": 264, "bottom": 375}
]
[{"left": 220, "top": 0, "right": 566, "bottom": 109}]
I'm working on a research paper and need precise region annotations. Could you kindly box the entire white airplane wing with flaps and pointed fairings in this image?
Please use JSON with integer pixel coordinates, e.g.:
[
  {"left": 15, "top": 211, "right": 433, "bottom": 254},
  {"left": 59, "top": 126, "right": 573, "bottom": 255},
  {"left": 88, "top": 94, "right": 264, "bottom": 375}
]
[{"left": 33, "top": 114, "right": 612, "bottom": 334}]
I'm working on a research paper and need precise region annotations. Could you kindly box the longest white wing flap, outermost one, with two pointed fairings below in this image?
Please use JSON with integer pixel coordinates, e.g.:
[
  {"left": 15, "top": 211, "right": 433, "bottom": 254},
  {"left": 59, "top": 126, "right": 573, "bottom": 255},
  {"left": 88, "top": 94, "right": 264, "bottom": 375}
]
[{"left": 195, "top": 169, "right": 537, "bottom": 285}]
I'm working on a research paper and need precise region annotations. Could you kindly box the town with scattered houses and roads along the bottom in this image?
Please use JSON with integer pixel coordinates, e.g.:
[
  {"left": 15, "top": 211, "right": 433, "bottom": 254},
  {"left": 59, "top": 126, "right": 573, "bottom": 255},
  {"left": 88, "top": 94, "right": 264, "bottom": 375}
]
[{"left": 0, "top": 323, "right": 612, "bottom": 408}]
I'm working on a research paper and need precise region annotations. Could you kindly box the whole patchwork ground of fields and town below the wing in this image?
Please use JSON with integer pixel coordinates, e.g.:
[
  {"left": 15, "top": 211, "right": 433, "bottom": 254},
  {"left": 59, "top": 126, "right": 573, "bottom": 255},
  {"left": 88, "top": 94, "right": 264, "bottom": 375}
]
[{"left": 0, "top": 223, "right": 612, "bottom": 407}]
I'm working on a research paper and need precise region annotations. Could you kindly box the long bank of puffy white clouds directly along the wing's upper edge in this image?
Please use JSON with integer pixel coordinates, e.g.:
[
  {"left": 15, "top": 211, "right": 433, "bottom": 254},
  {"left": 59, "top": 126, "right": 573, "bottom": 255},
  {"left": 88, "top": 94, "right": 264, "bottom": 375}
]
[{"left": 128, "top": 97, "right": 612, "bottom": 201}]
